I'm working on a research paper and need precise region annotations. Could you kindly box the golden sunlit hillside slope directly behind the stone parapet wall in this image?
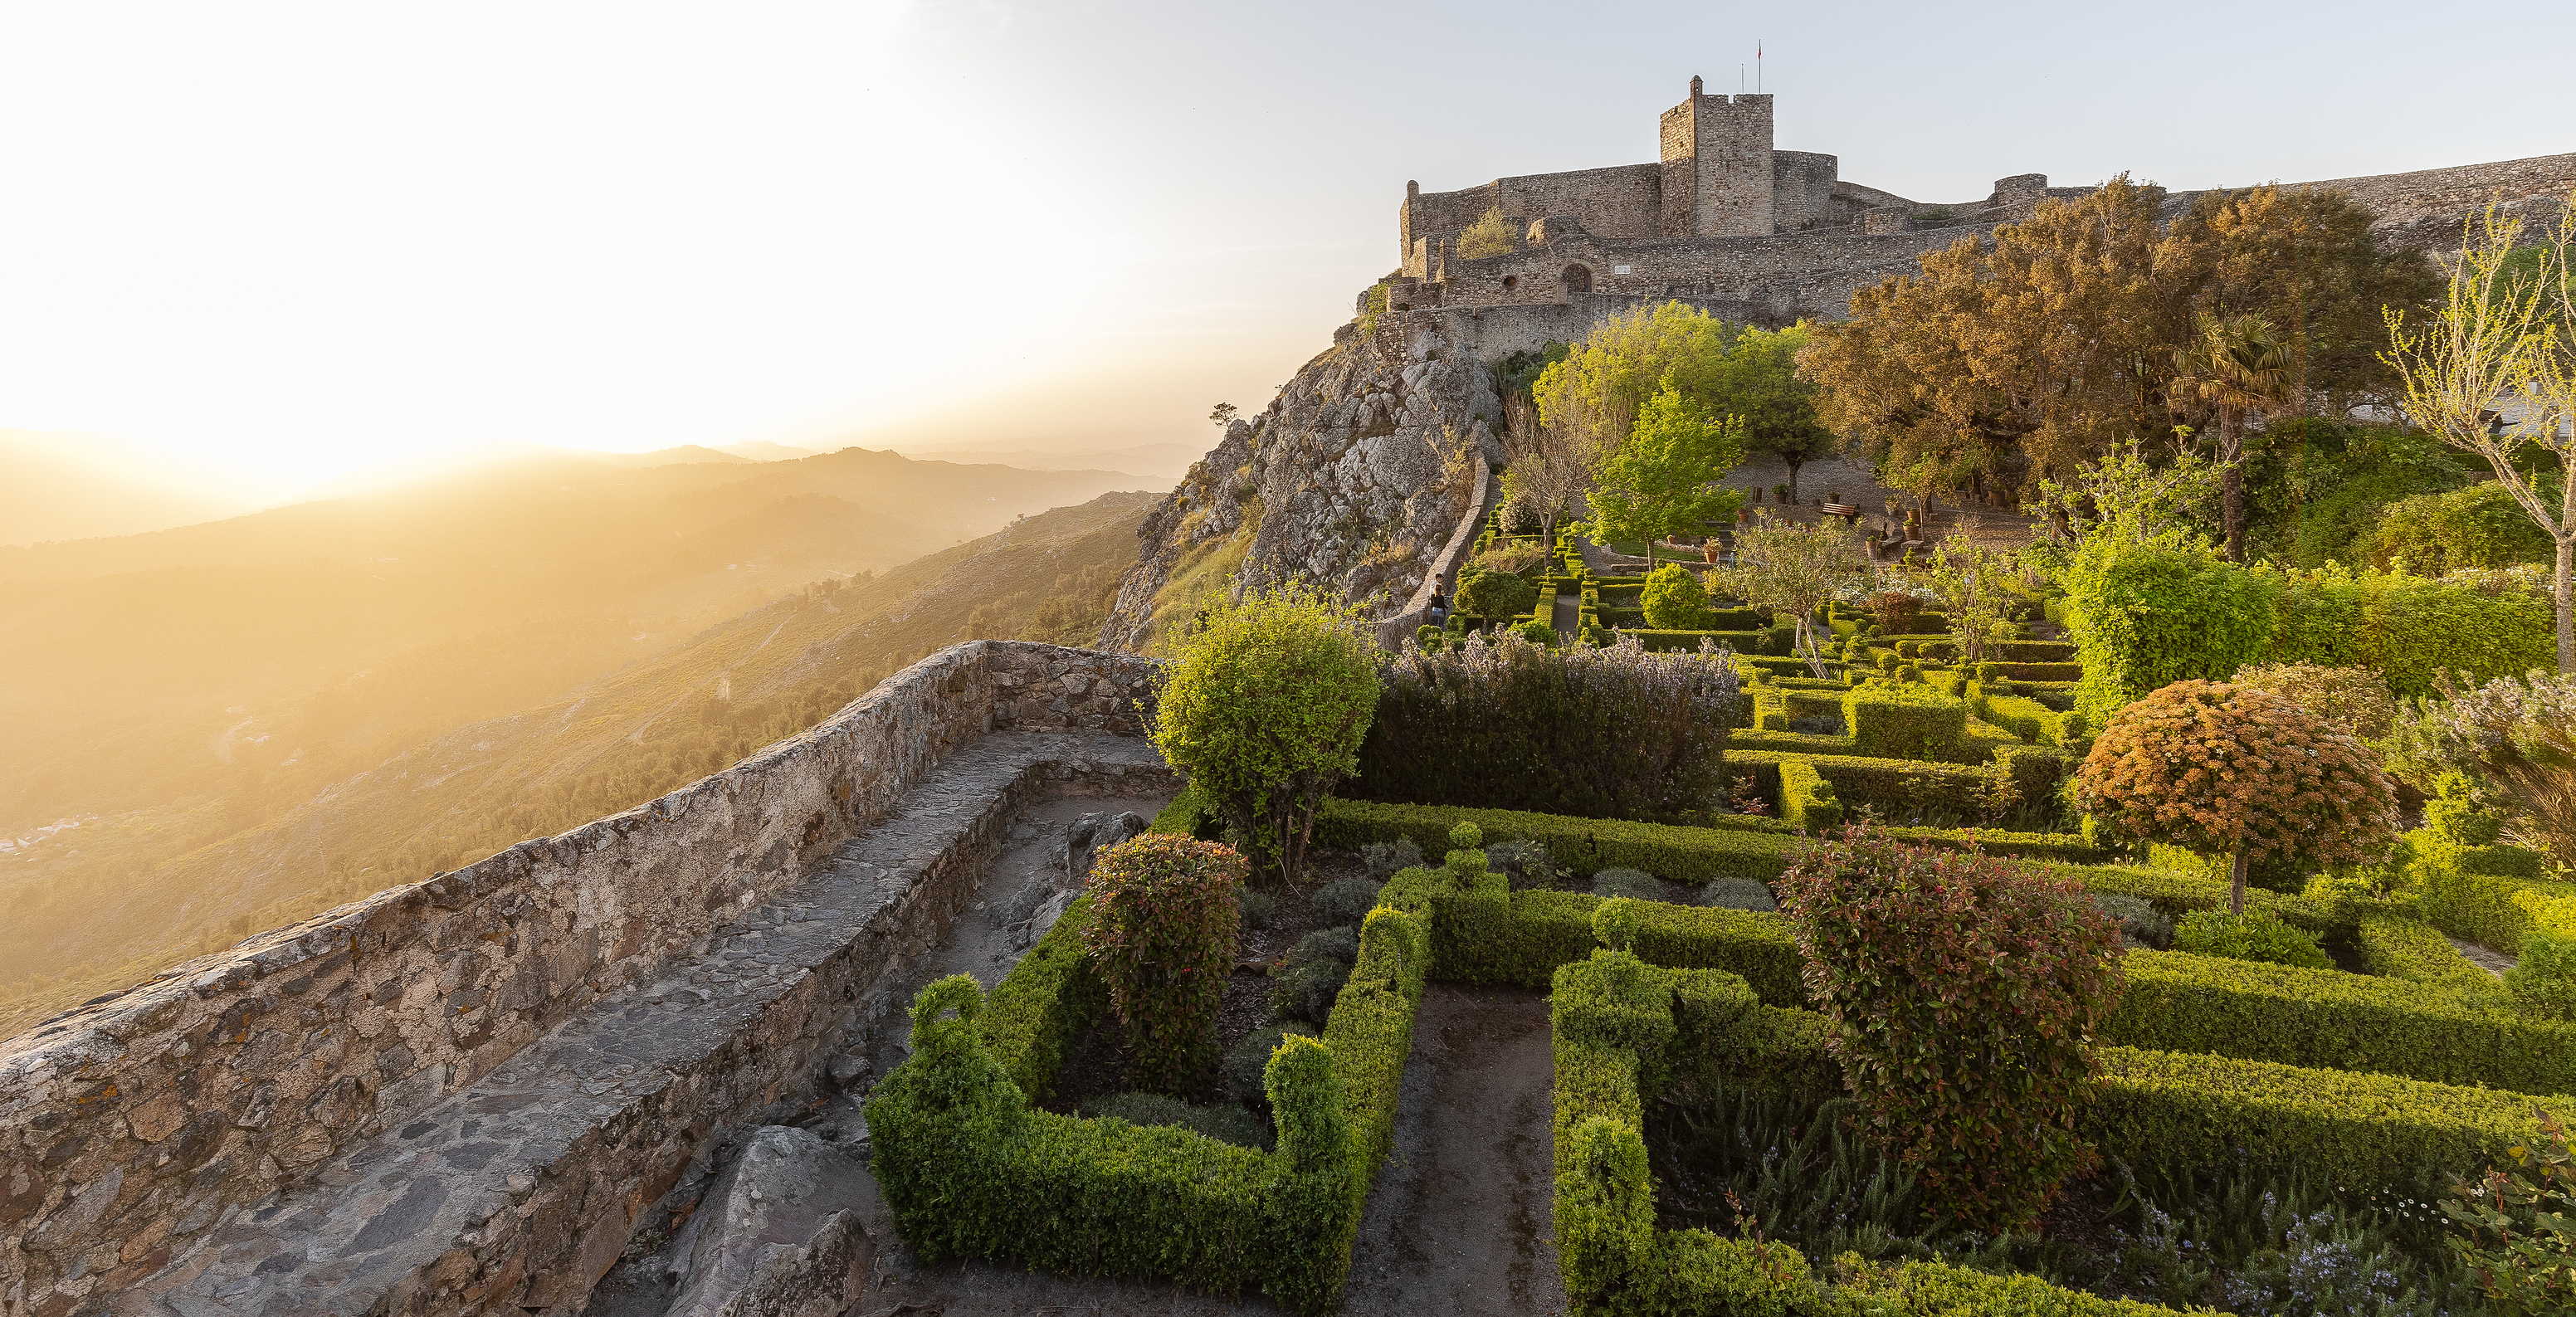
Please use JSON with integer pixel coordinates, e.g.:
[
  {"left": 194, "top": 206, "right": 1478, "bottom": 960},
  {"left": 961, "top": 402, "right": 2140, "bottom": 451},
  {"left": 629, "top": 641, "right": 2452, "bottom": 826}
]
[{"left": 0, "top": 490, "right": 1151, "bottom": 1036}]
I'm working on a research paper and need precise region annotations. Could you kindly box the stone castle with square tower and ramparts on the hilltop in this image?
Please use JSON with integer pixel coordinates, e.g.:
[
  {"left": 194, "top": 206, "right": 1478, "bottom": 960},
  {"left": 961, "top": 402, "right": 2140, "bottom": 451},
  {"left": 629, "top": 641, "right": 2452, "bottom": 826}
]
[{"left": 1360, "top": 77, "right": 2576, "bottom": 356}]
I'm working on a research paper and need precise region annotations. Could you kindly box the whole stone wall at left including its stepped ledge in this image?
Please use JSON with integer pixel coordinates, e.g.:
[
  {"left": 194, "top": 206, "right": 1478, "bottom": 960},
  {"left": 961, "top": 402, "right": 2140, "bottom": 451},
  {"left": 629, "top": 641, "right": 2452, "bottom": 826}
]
[{"left": 0, "top": 641, "right": 1169, "bottom": 1317}]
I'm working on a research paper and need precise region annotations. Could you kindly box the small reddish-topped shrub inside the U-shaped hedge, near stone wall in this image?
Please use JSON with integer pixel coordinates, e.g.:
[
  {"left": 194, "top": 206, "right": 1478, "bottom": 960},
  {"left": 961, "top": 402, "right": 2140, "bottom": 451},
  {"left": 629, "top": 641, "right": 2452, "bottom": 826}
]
[{"left": 1082, "top": 832, "right": 1252, "bottom": 1095}]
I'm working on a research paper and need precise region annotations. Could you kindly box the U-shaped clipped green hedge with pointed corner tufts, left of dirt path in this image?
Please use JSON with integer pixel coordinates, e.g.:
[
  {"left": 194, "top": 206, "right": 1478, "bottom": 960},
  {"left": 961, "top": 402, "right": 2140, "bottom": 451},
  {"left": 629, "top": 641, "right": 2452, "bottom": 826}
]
[{"left": 868, "top": 871, "right": 1430, "bottom": 1315}]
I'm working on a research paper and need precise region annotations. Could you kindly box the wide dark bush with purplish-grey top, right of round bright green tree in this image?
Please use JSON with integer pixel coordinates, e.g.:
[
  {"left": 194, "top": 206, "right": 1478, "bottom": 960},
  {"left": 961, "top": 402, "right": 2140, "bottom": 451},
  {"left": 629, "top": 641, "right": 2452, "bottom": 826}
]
[{"left": 1349, "top": 637, "right": 1739, "bottom": 820}]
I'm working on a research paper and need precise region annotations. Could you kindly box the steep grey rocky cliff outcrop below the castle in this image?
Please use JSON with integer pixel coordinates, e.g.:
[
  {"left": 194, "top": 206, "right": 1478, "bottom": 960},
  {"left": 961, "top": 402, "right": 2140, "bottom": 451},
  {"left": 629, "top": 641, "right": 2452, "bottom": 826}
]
[{"left": 1100, "top": 317, "right": 1502, "bottom": 650}]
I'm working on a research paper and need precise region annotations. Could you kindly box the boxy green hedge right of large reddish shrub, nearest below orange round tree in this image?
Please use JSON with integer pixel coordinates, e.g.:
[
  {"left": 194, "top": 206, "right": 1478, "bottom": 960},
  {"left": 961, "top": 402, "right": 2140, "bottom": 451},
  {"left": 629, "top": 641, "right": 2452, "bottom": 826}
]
[{"left": 2102, "top": 951, "right": 2576, "bottom": 1093}]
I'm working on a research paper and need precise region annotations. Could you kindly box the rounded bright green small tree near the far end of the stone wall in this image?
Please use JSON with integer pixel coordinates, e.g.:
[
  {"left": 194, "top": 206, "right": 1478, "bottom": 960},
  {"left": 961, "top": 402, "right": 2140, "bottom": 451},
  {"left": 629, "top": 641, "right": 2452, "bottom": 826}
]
[{"left": 1151, "top": 578, "right": 1380, "bottom": 881}]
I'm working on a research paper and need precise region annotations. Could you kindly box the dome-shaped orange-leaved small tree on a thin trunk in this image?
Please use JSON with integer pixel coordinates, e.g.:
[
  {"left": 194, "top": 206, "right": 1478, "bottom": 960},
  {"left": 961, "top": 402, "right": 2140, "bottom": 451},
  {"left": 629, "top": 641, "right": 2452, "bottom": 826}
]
[{"left": 2076, "top": 680, "right": 2398, "bottom": 915}]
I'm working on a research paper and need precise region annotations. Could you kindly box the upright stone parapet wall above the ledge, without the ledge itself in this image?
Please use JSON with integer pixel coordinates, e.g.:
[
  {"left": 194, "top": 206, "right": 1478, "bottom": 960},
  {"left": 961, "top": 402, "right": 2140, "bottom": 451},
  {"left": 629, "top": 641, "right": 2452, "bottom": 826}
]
[{"left": 0, "top": 641, "right": 1157, "bottom": 1315}]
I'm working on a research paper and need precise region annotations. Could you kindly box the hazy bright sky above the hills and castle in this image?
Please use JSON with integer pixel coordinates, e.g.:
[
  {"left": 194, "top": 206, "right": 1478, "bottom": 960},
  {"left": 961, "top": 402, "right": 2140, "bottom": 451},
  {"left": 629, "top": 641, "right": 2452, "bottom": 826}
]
[{"left": 0, "top": 0, "right": 2576, "bottom": 487}]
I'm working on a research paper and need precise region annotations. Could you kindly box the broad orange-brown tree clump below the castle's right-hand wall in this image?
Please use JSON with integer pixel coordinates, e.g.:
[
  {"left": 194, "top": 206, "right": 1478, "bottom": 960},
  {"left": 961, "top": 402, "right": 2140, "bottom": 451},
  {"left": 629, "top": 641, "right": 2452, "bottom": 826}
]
[{"left": 1801, "top": 175, "right": 2437, "bottom": 497}]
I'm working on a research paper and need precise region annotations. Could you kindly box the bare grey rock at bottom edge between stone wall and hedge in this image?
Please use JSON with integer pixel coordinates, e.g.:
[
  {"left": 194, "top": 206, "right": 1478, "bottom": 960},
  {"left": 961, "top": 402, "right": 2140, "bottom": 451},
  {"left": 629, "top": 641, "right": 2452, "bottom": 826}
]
[{"left": 670, "top": 1126, "right": 876, "bottom": 1317}]
